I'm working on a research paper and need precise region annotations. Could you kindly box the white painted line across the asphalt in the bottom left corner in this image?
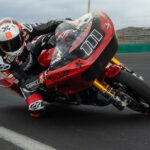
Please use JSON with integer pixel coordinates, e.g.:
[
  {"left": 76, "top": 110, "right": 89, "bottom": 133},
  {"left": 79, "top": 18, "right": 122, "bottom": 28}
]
[{"left": 0, "top": 127, "right": 56, "bottom": 150}]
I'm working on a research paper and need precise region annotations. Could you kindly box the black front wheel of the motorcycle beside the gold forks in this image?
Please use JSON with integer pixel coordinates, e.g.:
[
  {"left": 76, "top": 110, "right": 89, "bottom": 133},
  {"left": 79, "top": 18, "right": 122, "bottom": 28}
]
[{"left": 108, "top": 71, "right": 150, "bottom": 113}]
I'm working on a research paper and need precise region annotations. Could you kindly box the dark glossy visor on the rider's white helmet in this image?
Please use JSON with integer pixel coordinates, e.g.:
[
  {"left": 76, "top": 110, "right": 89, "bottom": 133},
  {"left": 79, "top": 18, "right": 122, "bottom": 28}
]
[{"left": 0, "top": 34, "right": 23, "bottom": 52}]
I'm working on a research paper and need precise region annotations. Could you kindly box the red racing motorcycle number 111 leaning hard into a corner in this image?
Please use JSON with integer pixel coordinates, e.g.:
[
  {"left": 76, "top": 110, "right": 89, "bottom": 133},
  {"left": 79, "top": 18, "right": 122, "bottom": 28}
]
[{"left": 0, "top": 11, "right": 150, "bottom": 113}]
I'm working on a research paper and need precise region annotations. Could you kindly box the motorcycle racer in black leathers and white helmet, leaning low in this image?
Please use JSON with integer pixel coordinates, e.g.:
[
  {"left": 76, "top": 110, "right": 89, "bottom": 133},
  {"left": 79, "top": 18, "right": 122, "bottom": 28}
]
[{"left": 0, "top": 18, "right": 63, "bottom": 117}]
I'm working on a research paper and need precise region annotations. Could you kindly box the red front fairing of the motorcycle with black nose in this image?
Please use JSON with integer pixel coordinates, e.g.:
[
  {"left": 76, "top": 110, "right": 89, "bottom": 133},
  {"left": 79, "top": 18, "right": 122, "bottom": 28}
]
[{"left": 46, "top": 11, "right": 118, "bottom": 94}]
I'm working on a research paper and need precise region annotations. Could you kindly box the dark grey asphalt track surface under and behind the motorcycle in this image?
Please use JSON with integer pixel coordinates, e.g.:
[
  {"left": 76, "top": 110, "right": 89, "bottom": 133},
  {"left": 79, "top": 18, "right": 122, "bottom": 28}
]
[{"left": 0, "top": 53, "right": 150, "bottom": 150}]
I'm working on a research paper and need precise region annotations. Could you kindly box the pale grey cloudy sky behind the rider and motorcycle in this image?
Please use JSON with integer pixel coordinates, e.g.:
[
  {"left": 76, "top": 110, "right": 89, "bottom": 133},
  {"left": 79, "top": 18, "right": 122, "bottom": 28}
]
[{"left": 0, "top": 0, "right": 150, "bottom": 29}]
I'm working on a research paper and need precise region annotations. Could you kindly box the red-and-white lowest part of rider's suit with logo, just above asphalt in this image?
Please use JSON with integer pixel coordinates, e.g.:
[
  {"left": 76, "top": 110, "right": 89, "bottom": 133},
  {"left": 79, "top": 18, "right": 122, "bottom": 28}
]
[{"left": 26, "top": 93, "right": 45, "bottom": 117}]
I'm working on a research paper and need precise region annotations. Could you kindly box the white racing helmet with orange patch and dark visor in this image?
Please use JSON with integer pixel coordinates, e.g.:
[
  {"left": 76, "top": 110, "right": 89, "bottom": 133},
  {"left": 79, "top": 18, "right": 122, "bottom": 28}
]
[{"left": 0, "top": 18, "right": 25, "bottom": 57}]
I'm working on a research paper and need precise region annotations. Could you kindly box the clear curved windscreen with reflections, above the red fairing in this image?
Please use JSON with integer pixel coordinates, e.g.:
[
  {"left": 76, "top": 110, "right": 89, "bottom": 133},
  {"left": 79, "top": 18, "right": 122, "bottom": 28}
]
[{"left": 51, "top": 14, "right": 93, "bottom": 69}]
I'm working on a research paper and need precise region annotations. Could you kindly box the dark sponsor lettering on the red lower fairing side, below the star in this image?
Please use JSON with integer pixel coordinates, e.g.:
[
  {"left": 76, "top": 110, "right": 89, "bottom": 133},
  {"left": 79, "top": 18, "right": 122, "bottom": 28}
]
[{"left": 48, "top": 70, "right": 70, "bottom": 81}]
